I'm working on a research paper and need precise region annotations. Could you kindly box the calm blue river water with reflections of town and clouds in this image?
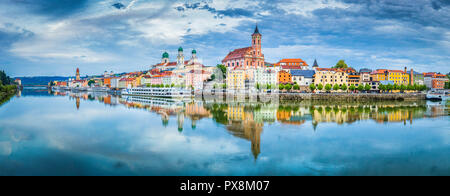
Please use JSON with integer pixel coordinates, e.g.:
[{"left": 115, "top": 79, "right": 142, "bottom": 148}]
[{"left": 0, "top": 89, "right": 450, "bottom": 176}]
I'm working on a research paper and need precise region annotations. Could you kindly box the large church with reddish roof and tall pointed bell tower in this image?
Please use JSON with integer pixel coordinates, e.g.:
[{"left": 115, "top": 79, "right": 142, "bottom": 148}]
[{"left": 222, "top": 26, "right": 265, "bottom": 69}]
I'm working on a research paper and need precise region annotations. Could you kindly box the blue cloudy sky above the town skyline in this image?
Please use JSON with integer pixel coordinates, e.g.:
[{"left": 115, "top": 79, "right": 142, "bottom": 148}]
[{"left": 0, "top": 0, "right": 450, "bottom": 77}]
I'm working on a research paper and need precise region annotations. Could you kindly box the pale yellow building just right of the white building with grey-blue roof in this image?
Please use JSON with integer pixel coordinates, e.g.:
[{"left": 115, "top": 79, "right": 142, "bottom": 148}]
[{"left": 314, "top": 68, "right": 348, "bottom": 87}]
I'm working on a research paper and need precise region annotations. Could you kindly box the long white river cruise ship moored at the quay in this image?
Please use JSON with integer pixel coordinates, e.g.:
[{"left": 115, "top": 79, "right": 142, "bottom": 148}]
[{"left": 122, "top": 87, "right": 193, "bottom": 98}]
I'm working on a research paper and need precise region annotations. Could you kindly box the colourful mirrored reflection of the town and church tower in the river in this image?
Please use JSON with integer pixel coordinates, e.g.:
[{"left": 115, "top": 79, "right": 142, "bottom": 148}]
[{"left": 54, "top": 93, "right": 450, "bottom": 160}]
